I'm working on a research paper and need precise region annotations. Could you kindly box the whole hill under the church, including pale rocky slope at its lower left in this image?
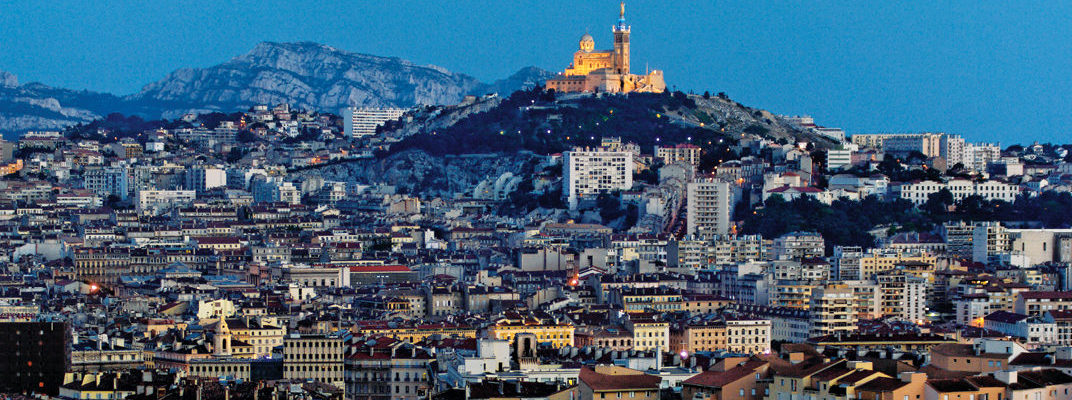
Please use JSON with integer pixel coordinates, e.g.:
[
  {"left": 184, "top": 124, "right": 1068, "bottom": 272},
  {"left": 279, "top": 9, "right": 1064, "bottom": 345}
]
[{"left": 300, "top": 90, "right": 832, "bottom": 196}]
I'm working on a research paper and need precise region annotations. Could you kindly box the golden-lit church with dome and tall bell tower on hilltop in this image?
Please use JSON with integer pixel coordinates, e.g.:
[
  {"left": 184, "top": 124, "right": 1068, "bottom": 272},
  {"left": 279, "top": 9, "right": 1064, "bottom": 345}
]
[{"left": 545, "top": 2, "right": 667, "bottom": 93}]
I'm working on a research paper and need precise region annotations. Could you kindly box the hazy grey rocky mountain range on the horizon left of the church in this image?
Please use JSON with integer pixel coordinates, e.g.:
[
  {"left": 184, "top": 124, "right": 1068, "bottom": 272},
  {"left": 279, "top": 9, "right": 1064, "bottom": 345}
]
[{"left": 0, "top": 42, "right": 553, "bottom": 137}]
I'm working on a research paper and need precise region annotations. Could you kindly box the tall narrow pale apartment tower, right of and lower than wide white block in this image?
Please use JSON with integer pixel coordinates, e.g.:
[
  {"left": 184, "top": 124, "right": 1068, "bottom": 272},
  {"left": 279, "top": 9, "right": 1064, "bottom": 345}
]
[{"left": 686, "top": 177, "right": 733, "bottom": 237}]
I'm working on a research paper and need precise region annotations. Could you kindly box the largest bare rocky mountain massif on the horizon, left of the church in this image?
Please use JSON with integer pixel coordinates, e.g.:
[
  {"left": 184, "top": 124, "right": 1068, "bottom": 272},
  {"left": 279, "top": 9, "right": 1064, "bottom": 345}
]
[{"left": 129, "top": 43, "right": 501, "bottom": 116}]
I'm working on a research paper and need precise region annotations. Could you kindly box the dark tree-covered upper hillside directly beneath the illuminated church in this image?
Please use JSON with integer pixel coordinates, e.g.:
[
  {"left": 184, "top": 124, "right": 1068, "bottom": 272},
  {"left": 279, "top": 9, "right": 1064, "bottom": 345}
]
[{"left": 386, "top": 90, "right": 833, "bottom": 159}]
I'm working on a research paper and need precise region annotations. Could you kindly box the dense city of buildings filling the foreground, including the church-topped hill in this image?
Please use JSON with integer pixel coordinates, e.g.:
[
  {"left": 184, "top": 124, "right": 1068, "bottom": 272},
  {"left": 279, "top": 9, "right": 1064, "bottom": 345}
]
[{"left": 0, "top": 3, "right": 1072, "bottom": 400}]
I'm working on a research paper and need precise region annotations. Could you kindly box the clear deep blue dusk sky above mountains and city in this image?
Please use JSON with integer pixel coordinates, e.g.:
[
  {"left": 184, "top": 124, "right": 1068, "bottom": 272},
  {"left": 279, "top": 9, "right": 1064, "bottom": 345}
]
[{"left": 0, "top": 0, "right": 1072, "bottom": 144}]
